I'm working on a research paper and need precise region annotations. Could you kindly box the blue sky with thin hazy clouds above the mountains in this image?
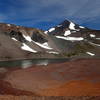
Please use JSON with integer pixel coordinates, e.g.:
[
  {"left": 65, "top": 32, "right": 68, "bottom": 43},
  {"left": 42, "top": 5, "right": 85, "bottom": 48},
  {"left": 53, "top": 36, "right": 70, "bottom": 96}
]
[{"left": 0, "top": 0, "right": 100, "bottom": 30}]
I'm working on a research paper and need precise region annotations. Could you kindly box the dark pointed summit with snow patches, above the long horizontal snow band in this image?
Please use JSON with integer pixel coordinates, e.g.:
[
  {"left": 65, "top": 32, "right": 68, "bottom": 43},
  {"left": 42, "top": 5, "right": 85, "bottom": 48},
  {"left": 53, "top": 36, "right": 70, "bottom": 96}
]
[{"left": 45, "top": 20, "right": 87, "bottom": 37}]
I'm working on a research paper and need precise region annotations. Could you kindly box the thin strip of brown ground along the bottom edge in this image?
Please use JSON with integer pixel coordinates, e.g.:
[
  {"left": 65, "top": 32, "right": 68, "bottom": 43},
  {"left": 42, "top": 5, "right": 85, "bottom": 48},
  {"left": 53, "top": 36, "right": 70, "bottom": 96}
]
[{"left": 0, "top": 95, "right": 100, "bottom": 100}]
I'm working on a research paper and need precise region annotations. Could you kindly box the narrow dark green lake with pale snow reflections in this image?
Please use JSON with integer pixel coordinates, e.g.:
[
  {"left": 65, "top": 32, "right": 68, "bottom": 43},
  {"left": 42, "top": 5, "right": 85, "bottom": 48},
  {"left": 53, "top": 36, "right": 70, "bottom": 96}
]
[{"left": 0, "top": 59, "right": 69, "bottom": 68}]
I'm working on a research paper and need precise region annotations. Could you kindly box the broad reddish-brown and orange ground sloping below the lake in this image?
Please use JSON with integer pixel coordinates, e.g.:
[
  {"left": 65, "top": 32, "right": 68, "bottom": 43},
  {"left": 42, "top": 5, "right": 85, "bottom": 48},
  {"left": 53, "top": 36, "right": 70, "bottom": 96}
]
[{"left": 0, "top": 59, "right": 100, "bottom": 96}]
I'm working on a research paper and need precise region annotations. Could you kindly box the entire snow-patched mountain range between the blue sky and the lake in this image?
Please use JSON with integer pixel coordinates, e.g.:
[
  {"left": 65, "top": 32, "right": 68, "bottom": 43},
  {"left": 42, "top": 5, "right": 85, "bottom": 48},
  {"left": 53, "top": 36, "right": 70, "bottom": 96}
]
[{"left": 0, "top": 20, "right": 100, "bottom": 60}]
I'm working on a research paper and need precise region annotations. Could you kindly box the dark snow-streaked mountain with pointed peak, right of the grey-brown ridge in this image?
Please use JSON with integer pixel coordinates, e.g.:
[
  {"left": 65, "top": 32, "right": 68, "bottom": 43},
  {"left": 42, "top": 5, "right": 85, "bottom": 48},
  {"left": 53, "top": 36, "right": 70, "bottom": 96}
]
[{"left": 45, "top": 20, "right": 100, "bottom": 56}]
